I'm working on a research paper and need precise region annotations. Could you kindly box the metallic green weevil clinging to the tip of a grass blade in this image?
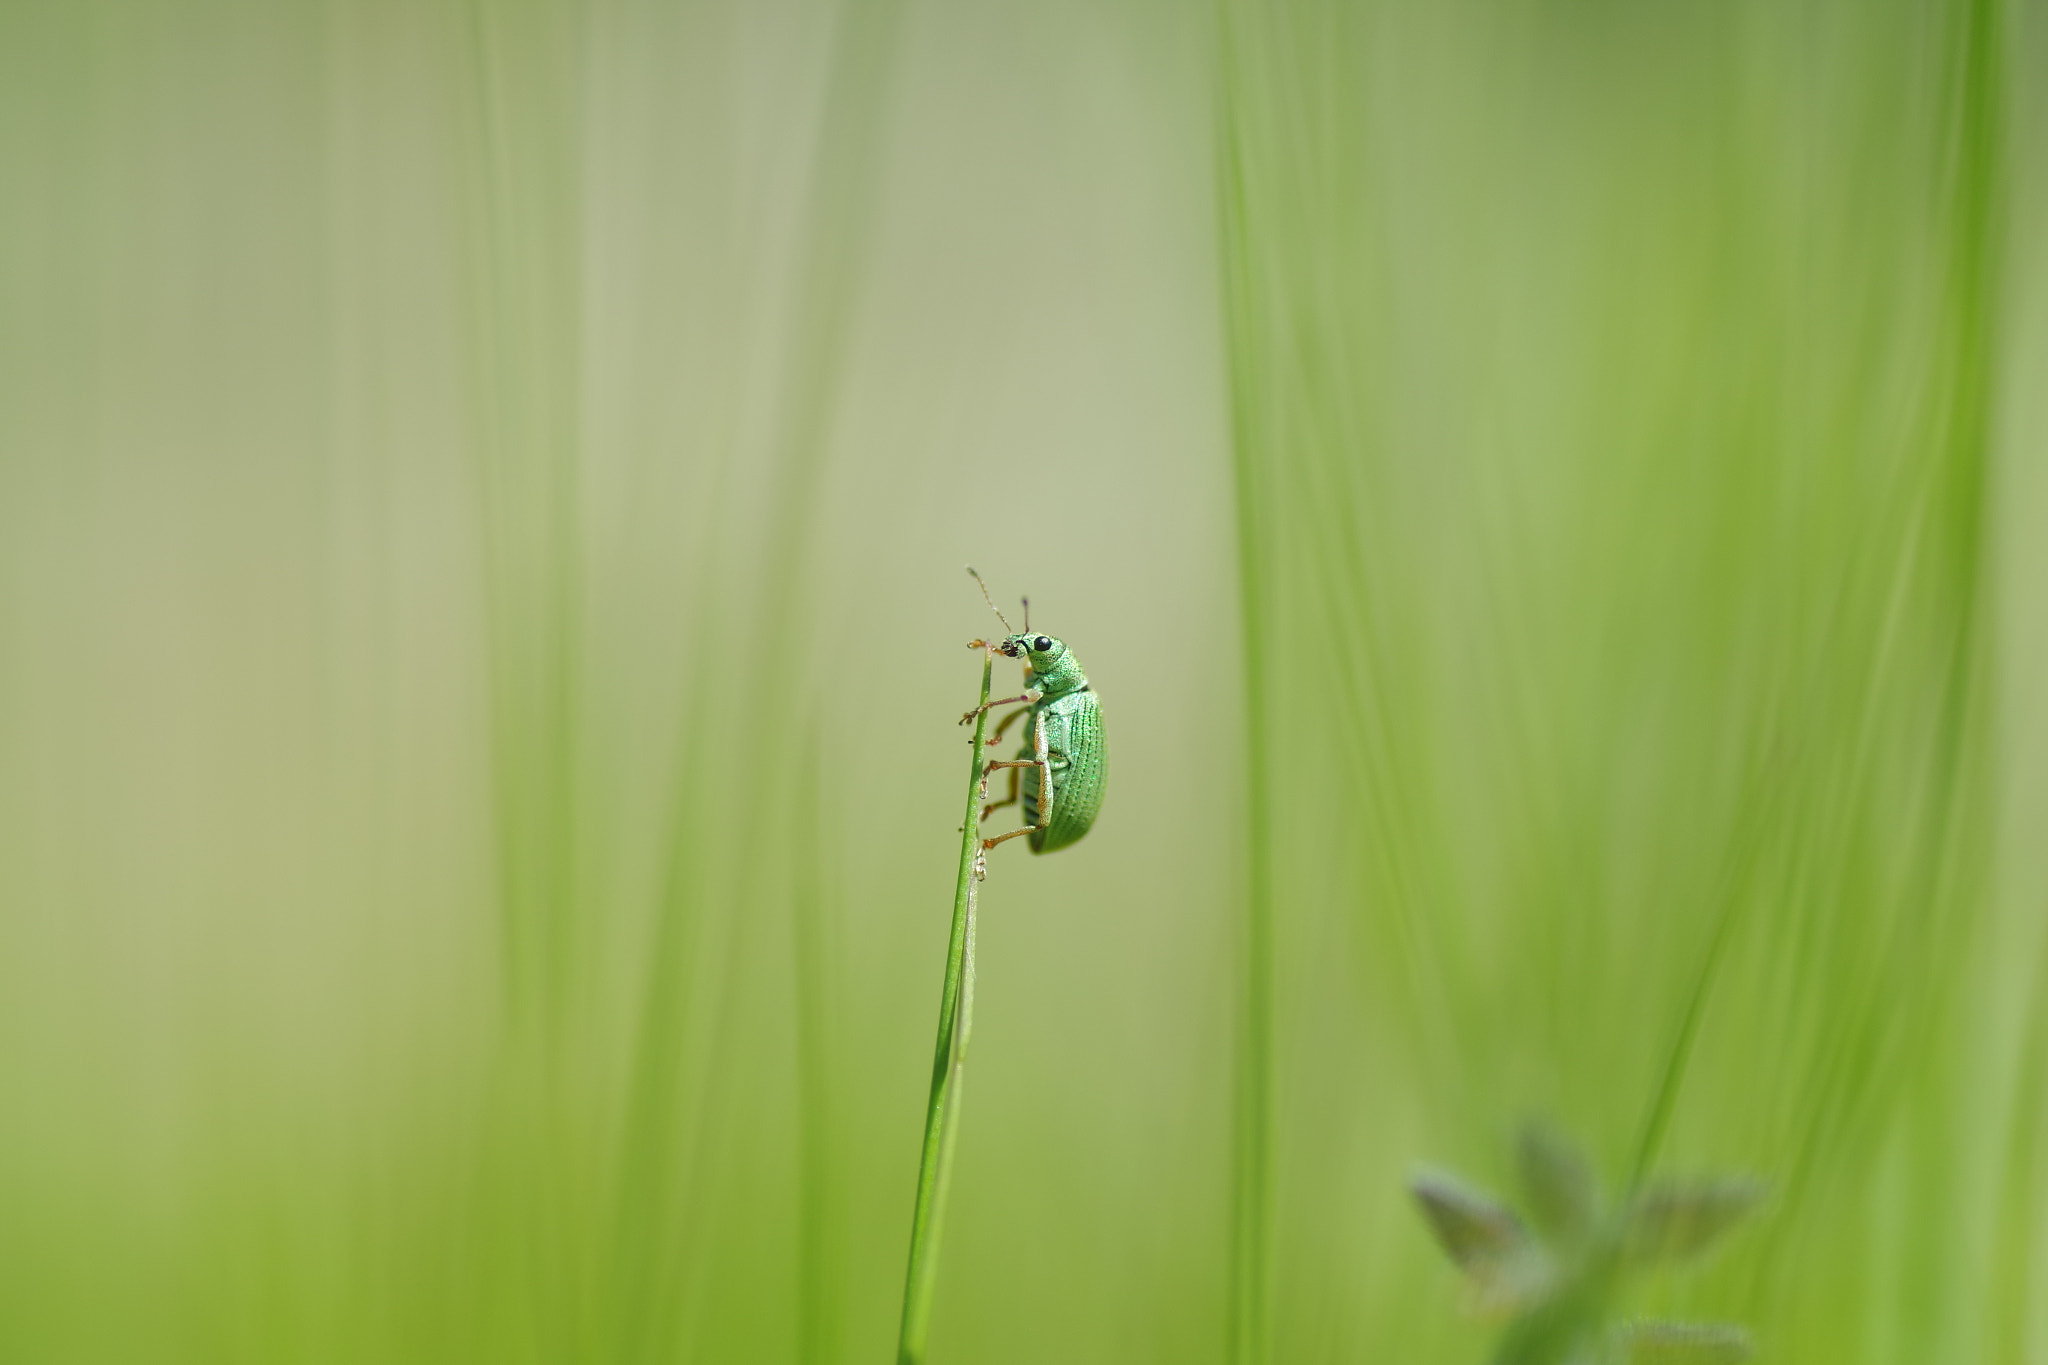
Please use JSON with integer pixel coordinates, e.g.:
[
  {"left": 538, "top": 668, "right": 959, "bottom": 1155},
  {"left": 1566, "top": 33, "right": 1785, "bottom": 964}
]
[{"left": 961, "top": 569, "right": 1108, "bottom": 871}]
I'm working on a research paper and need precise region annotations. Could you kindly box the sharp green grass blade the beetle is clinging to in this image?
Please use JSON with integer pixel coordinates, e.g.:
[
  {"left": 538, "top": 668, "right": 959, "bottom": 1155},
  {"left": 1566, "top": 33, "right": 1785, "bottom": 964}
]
[{"left": 897, "top": 647, "right": 995, "bottom": 1365}]
